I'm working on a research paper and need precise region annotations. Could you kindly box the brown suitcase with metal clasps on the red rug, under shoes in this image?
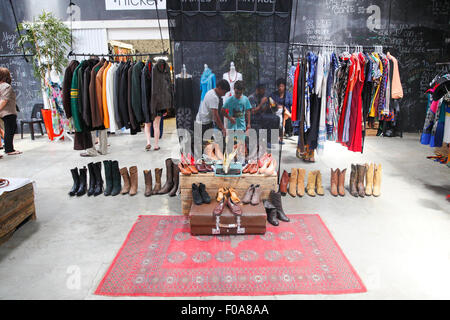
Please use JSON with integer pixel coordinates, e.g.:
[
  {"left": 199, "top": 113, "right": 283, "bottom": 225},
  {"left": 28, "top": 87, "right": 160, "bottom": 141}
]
[{"left": 189, "top": 200, "right": 267, "bottom": 236}]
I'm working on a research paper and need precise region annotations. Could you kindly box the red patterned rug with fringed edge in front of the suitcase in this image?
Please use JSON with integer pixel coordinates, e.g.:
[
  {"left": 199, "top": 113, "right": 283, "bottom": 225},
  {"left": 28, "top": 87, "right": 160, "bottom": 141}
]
[{"left": 95, "top": 215, "right": 366, "bottom": 297}]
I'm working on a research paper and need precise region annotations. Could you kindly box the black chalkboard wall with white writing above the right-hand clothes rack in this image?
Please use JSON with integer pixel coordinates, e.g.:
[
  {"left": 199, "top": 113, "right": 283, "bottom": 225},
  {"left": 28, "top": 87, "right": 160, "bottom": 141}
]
[{"left": 291, "top": 0, "right": 450, "bottom": 132}]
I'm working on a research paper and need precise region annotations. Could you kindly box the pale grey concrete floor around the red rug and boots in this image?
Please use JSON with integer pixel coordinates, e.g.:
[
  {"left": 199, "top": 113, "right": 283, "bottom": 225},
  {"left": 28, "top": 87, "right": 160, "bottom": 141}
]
[{"left": 0, "top": 117, "right": 450, "bottom": 300}]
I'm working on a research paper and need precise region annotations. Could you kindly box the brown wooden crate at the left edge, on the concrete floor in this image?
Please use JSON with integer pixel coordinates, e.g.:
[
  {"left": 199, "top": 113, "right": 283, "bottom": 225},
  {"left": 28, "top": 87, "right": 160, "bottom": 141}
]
[{"left": 0, "top": 183, "right": 36, "bottom": 245}]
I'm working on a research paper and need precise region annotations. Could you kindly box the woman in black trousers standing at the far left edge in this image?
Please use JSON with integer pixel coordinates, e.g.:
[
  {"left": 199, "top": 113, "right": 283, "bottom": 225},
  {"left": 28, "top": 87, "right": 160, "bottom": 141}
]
[{"left": 0, "top": 68, "right": 21, "bottom": 155}]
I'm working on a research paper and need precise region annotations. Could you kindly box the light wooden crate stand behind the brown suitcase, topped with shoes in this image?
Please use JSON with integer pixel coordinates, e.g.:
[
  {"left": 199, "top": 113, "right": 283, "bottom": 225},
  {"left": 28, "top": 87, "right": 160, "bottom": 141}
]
[{"left": 180, "top": 172, "right": 278, "bottom": 215}]
